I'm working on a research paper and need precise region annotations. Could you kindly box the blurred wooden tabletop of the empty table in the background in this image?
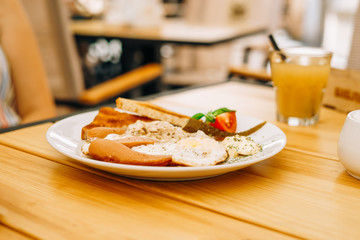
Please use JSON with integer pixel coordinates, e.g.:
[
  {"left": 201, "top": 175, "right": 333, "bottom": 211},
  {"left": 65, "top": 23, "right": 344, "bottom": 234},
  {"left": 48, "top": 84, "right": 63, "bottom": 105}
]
[{"left": 71, "top": 20, "right": 266, "bottom": 45}]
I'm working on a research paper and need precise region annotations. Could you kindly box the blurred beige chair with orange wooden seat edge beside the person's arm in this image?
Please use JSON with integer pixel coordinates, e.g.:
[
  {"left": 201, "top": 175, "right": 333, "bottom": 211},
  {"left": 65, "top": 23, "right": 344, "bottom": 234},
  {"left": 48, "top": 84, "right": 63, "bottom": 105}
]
[{"left": 22, "top": 0, "right": 162, "bottom": 105}]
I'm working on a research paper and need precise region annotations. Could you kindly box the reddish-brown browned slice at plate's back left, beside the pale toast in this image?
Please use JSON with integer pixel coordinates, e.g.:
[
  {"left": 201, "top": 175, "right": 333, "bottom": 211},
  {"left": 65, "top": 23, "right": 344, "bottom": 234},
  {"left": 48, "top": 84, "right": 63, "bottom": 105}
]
[{"left": 81, "top": 107, "right": 152, "bottom": 140}]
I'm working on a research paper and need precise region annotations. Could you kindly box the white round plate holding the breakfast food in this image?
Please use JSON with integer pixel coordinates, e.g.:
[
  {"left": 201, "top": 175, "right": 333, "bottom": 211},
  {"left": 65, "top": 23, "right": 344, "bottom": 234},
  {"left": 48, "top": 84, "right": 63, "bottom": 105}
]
[{"left": 46, "top": 111, "right": 286, "bottom": 181}]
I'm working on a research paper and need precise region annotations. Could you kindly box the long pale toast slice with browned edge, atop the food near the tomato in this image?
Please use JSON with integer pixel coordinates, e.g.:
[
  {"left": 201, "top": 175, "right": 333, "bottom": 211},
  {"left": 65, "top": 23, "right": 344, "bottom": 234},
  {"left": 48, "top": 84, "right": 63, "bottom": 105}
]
[{"left": 116, "top": 98, "right": 190, "bottom": 127}]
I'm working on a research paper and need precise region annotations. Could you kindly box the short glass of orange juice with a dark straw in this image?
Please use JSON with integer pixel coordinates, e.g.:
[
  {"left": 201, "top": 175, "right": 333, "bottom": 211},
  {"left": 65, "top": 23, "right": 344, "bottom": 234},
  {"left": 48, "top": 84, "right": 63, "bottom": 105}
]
[{"left": 270, "top": 47, "right": 332, "bottom": 126}]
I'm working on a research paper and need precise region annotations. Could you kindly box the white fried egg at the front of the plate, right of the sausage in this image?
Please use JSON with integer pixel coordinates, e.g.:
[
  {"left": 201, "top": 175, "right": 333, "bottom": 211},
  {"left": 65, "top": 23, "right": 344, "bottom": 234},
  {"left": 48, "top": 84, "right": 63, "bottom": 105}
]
[{"left": 172, "top": 137, "right": 228, "bottom": 166}]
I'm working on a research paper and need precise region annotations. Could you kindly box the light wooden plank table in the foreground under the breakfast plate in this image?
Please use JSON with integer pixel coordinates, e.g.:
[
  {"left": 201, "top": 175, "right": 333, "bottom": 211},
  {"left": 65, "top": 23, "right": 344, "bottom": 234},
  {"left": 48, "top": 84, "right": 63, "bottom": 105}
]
[{"left": 0, "top": 82, "right": 360, "bottom": 239}]
